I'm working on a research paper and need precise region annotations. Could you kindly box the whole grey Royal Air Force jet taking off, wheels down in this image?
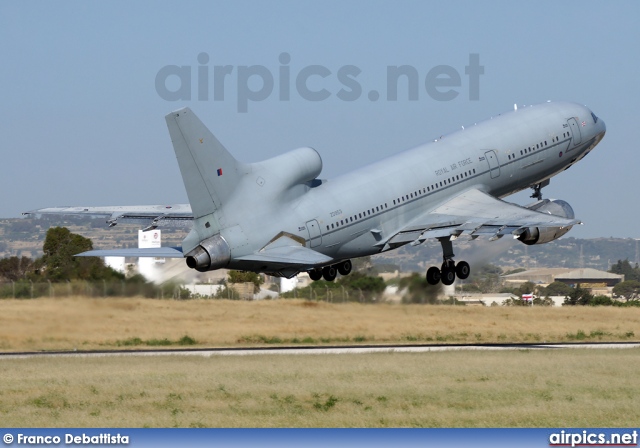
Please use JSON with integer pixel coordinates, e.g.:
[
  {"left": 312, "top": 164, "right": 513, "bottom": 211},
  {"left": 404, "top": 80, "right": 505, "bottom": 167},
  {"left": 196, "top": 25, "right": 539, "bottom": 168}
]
[{"left": 25, "top": 102, "right": 606, "bottom": 285}]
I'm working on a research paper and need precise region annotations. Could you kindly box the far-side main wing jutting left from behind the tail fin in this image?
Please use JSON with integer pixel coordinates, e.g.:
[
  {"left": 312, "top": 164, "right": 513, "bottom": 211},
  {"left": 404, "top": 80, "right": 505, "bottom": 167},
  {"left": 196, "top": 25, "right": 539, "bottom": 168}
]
[{"left": 23, "top": 204, "right": 193, "bottom": 231}]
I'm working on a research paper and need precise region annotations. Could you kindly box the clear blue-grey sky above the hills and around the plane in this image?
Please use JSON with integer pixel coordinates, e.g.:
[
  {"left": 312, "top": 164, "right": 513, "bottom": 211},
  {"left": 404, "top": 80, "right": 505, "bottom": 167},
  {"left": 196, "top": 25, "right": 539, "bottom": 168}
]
[{"left": 0, "top": 1, "right": 640, "bottom": 237}]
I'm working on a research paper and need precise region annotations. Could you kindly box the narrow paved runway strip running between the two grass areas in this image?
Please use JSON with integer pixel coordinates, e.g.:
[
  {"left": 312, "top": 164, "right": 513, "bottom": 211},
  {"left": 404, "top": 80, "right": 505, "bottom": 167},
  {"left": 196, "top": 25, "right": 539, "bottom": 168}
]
[{"left": 0, "top": 342, "right": 640, "bottom": 360}]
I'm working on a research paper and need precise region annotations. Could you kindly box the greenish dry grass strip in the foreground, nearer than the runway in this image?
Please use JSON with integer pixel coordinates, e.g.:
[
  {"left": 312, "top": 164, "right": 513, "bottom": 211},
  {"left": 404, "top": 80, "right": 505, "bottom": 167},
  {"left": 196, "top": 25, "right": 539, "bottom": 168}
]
[{"left": 0, "top": 349, "right": 640, "bottom": 427}]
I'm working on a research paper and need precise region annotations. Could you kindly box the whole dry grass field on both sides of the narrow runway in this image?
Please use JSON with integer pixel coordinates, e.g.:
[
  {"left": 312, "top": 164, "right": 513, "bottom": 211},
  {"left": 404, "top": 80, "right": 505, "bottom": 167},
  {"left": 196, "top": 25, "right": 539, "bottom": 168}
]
[{"left": 0, "top": 297, "right": 640, "bottom": 427}]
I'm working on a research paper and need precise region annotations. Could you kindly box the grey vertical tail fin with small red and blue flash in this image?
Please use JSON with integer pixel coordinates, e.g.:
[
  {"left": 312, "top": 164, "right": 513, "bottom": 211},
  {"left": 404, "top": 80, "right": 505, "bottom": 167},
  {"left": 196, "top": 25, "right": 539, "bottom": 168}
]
[{"left": 165, "top": 107, "right": 243, "bottom": 218}]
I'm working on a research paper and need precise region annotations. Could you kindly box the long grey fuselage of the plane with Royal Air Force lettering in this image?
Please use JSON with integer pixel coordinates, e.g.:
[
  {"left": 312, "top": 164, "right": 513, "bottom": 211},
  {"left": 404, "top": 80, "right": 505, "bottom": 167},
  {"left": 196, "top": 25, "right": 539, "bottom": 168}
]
[{"left": 221, "top": 102, "right": 605, "bottom": 270}]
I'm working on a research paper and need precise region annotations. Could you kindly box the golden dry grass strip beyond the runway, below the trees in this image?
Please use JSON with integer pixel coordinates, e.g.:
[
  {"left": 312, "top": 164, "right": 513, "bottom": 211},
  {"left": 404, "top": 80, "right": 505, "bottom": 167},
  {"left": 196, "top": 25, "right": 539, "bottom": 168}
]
[{"left": 0, "top": 297, "right": 640, "bottom": 351}]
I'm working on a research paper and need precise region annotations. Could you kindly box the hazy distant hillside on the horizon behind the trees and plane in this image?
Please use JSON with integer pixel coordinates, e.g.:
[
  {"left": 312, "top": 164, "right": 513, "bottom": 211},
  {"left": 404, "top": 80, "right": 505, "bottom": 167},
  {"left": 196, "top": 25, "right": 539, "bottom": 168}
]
[{"left": 0, "top": 216, "right": 638, "bottom": 272}]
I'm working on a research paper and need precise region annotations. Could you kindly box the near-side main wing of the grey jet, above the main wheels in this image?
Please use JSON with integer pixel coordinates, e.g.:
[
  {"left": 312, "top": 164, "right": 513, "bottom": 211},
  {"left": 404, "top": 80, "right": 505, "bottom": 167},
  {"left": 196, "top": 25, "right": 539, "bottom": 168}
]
[{"left": 379, "top": 189, "right": 580, "bottom": 250}]
